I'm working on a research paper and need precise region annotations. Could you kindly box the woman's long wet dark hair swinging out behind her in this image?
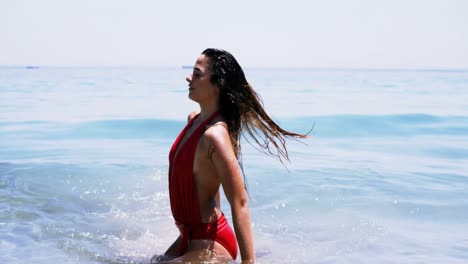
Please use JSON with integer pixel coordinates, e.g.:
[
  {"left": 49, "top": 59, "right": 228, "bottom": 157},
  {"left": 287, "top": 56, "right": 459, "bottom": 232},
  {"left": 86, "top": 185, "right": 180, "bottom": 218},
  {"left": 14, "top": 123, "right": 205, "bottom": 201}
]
[{"left": 202, "top": 48, "right": 307, "bottom": 162}]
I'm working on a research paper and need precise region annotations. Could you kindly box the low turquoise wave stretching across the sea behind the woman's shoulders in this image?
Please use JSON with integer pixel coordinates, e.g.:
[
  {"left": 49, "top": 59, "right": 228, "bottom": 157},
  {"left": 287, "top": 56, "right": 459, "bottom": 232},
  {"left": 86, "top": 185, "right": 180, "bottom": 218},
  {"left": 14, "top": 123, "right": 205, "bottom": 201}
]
[{"left": 0, "top": 114, "right": 468, "bottom": 139}]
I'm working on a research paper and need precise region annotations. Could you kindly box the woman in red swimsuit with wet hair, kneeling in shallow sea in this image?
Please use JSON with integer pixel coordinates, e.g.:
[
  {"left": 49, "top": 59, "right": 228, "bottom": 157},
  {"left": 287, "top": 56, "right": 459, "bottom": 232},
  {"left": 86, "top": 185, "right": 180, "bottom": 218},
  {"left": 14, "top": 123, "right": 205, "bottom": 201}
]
[{"left": 152, "top": 49, "right": 306, "bottom": 263}]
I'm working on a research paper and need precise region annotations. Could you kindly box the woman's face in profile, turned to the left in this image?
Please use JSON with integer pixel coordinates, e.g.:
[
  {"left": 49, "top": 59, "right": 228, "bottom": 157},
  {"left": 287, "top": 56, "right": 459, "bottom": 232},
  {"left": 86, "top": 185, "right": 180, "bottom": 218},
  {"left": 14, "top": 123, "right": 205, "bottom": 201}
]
[{"left": 186, "top": 54, "right": 219, "bottom": 104}]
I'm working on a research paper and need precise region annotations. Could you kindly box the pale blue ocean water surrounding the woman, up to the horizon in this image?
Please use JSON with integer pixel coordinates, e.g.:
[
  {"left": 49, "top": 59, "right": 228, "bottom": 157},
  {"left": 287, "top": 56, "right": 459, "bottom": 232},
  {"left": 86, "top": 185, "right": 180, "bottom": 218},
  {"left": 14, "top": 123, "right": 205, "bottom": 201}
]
[{"left": 0, "top": 67, "right": 468, "bottom": 264}]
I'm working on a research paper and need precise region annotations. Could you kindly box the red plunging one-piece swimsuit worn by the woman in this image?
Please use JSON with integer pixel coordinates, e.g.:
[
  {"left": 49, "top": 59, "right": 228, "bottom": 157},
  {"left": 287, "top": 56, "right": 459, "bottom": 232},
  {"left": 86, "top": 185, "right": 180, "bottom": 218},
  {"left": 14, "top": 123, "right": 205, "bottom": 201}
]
[{"left": 169, "top": 112, "right": 237, "bottom": 259}]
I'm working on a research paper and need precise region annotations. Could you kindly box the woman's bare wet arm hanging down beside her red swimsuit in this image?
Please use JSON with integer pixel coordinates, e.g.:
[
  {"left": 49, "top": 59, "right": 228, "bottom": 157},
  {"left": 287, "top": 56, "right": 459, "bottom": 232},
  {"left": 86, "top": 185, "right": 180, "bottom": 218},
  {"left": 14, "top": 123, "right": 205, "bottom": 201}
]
[{"left": 205, "top": 126, "right": 255, "bottom": 263}]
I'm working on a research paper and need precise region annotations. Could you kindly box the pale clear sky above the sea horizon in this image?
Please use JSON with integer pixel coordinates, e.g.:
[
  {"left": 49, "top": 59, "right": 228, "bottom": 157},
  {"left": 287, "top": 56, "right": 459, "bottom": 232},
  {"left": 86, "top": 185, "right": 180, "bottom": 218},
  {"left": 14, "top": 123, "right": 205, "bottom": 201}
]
[{"left": 0, "top": 0, "right": 468, "bottom": 69}]
